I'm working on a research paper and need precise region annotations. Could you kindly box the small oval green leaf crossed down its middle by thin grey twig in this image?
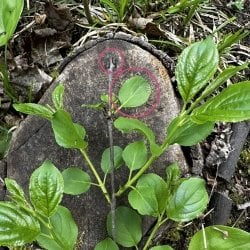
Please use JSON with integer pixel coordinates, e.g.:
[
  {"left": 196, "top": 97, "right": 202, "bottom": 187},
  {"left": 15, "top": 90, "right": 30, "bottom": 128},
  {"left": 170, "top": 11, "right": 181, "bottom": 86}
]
[{"left": 101, "top": 146, "right": 123, "bottom": 174}]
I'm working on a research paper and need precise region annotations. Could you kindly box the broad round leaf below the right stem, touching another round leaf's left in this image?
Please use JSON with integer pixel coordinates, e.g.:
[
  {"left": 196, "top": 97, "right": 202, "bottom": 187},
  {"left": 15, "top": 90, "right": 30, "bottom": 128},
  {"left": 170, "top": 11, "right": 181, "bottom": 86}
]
[{"left": 128, "top": 174, "right": 168, "bottom": 217}]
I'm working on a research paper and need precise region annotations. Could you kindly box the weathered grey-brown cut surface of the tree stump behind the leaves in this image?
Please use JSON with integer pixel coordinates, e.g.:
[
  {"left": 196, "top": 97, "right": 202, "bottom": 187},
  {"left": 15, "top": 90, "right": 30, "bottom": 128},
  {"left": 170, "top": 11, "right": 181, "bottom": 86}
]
[{"left": 7, "top": 34, "right": 188, "bottom": 250}]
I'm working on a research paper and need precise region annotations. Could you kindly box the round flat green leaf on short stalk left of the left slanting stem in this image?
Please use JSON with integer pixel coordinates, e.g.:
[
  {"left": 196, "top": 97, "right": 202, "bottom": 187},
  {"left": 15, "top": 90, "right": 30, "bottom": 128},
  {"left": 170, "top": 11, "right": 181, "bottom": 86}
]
[{"left": 62, "top": 167, "right": 91, "bottom": 195}]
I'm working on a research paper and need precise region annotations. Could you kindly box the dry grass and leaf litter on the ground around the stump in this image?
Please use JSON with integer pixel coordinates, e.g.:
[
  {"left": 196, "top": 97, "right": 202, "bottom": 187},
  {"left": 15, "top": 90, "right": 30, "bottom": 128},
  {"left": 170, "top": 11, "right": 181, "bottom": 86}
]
[{"left": 0, "top": 0, "right": 250, "bottom": 249}]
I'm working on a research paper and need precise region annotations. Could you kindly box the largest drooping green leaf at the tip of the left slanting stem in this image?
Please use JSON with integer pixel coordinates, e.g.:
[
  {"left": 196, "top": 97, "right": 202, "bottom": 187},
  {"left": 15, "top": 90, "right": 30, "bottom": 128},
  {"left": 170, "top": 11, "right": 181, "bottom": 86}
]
[{"left": 52, "top": 109, "right": 87, "bottom": 149}]
